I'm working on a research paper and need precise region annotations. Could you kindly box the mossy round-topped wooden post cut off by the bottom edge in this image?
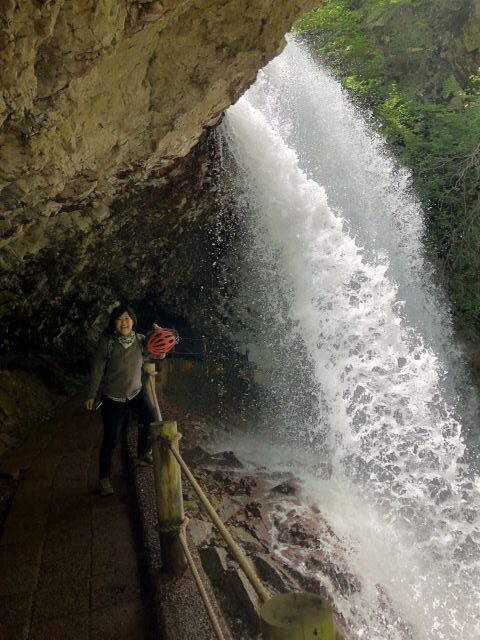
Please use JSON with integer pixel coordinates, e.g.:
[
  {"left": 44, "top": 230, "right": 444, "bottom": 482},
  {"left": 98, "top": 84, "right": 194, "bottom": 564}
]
[{"left": 260, "top": 593, "right": 338, "bottom": 640}]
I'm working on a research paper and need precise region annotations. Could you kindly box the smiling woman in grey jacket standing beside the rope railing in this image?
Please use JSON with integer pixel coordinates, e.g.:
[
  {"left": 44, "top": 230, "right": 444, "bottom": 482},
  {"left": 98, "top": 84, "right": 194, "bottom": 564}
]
[{"left": 85, "top": 305, "right": 161, "bottom": 496}]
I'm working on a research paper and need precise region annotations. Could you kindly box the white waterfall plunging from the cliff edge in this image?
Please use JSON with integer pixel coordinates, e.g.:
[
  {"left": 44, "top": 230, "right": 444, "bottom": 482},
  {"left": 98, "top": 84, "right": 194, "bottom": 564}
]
[{"left": 218, "top": 43, "right": 480, "bottom": 640}]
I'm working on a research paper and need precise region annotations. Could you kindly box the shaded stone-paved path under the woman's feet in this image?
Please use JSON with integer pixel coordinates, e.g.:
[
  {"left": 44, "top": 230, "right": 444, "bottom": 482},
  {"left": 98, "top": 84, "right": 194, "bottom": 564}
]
[{"left": 0, "top": 409, "right": 159, "bottom": 640}]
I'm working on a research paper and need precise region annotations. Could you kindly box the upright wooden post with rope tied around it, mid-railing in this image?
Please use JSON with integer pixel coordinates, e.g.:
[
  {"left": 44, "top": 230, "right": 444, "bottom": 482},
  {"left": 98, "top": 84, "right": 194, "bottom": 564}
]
[{"left": 150, "top": 422, "right": 187, "bottom": 575}]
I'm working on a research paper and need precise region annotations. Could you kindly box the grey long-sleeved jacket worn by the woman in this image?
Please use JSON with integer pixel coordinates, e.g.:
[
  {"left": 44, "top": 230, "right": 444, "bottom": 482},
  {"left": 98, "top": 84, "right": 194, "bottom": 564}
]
[{"left": 88, "top": 334, "right": 144, "bottom": 398}]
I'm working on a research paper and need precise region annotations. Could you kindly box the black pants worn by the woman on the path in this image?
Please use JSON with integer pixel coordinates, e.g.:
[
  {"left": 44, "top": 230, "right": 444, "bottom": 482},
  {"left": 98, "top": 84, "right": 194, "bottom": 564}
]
[{"left": 99, "top": 389, "right": 157, "bottom": 478}]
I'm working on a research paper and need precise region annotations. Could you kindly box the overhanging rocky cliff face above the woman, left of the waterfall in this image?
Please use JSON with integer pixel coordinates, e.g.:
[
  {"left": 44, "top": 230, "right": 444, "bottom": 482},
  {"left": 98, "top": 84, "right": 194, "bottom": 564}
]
[{"left": 0, "top": 0, "right": 316, "bottom": 351}]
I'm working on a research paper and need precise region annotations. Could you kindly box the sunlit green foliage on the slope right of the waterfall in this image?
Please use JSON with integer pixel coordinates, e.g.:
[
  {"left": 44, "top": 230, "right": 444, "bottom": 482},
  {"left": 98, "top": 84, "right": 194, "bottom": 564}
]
[{"left": 294, "top": 0, "right": 480, "bottom": 338}]
